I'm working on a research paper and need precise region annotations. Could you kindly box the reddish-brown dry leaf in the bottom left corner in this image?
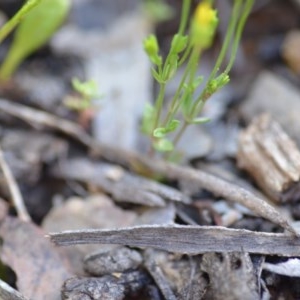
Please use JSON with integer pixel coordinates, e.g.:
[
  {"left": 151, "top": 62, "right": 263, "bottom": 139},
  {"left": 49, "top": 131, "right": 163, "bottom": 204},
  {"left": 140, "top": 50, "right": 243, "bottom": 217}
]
[{"left": 0, "top": 217, "right": 70, "bottom": 300}]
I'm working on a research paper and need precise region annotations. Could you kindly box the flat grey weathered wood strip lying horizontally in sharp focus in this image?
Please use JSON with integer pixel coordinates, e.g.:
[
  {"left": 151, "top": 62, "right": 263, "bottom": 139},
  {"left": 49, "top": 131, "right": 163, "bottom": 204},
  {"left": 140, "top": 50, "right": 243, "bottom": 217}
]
[{"left": 49, "top": 225, "right": 300, "bottom": 256}]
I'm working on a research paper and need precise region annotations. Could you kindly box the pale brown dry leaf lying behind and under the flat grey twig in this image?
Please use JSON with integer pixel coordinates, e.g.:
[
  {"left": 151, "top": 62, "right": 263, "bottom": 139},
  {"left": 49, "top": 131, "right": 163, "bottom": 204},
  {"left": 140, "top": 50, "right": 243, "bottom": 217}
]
[{"left": 42, "top": 195, "right": 136, "bottom": 275}]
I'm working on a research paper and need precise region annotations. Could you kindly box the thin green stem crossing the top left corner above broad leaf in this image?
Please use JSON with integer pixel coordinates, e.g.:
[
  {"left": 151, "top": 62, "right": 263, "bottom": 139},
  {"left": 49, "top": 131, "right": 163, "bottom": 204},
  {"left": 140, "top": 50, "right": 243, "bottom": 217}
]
[{"left": 0, "top": 0, "right": 42, "bottom": 43}]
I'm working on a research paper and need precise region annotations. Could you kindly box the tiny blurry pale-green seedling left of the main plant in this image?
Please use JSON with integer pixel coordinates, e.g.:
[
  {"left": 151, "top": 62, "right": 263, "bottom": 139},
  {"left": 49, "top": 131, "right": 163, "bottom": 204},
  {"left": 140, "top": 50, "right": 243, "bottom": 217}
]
[{"left": 64, "top": 78, "right": 101, "bottom": 111}]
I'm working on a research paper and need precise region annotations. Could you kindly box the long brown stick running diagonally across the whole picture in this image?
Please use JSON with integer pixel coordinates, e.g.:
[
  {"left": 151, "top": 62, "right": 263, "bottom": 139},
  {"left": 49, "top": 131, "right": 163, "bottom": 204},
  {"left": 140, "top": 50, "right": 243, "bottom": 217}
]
[{"left": 0, "top": 99, "right": 298, "bottom": 236}]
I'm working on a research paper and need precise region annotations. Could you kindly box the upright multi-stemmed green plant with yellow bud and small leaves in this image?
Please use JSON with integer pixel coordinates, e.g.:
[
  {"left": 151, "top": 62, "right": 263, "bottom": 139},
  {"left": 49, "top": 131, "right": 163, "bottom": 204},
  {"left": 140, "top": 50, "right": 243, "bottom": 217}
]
[{"left": 142, "top": 0, "right": 254, "bottom": 153}]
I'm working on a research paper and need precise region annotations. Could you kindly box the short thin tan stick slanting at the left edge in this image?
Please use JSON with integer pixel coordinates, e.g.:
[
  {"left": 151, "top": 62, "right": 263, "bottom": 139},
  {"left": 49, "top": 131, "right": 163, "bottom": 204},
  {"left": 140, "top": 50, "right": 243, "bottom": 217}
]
[{"left": 0, "top": 149, "right": 31, "bottom": 221}]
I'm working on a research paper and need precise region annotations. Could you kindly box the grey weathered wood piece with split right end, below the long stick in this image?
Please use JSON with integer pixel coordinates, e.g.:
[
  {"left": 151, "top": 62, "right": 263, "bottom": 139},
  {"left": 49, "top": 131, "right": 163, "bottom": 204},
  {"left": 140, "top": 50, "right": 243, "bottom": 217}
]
[{"left": 52, "top": 158, "right": 191, "bottom": 206}]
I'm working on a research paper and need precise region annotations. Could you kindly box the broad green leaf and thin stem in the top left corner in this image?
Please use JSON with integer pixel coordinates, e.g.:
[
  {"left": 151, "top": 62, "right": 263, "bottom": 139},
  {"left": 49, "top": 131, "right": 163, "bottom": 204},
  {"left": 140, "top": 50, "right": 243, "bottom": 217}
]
[{"left": 0, "top": 0, "right": 71, "bottom": 80}]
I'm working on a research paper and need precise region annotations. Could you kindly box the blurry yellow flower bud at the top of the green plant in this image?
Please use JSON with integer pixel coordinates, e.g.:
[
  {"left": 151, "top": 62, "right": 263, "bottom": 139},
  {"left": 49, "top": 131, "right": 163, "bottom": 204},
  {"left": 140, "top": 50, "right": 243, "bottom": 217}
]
[{"left": 191, "top": 1, "right": 219, "bottom": 49}]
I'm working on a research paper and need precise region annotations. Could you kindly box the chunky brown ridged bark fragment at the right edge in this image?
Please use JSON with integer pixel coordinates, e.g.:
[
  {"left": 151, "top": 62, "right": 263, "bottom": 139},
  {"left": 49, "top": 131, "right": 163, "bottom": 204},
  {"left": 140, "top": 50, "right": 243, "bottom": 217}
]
[{"left": 237, "top": 114, "right": 300, "bottom": 202}]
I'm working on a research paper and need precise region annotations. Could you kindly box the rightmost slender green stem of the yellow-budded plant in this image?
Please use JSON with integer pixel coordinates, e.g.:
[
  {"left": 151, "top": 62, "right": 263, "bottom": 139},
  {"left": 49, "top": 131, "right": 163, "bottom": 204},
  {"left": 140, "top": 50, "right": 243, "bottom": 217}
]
[{"left": 224, "top": 0, "right": 254, "bottom": 74}]
